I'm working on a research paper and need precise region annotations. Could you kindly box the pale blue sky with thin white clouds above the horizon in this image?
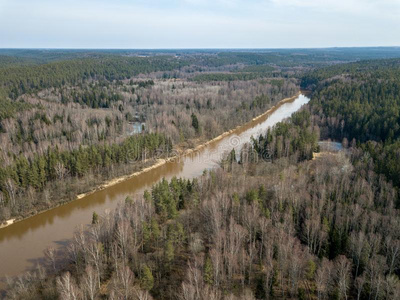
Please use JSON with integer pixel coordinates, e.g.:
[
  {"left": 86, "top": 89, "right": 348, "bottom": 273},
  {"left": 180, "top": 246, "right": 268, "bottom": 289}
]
[{"left": 0, "top": 0, "right": 400, "bottom": 49}]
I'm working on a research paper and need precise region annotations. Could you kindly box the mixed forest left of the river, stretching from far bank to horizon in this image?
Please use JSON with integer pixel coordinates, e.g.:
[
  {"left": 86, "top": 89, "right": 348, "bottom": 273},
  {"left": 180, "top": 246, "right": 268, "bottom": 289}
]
[{"left": 0, "top": 50, "right": 299, "bottom": 222}]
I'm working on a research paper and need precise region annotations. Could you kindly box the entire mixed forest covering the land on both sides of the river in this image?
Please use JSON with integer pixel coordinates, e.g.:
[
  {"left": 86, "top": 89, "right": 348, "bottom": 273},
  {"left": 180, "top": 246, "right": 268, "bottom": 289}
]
[{"left": 0, "top": 49, "right": 400, "bottom": 300}]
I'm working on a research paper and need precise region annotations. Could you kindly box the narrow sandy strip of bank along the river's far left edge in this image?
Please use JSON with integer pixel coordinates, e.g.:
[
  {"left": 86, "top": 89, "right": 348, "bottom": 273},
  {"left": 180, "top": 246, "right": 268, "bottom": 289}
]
[{"left": 0, "top": 91, "right": 301, "bottom": 228}]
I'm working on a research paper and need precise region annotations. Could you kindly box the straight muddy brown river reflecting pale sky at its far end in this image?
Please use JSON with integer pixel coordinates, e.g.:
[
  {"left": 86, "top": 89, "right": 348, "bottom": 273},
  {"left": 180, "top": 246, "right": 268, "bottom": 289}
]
[{"left": 0, "top": 95, "right": 309, "bottom": 278}]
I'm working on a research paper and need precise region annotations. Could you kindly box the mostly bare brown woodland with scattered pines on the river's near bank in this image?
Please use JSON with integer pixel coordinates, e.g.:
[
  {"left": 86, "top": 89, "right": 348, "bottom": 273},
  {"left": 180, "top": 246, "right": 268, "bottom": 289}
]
[{"left": 7, "top": 75, "right": 400, "bottom": 300}]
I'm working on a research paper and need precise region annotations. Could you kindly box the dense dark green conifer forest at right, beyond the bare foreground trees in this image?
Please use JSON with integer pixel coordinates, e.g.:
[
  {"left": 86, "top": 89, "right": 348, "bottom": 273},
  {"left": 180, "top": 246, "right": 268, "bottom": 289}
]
[{"left": 302, "top": 59, "right": 400, "bottom": 187}]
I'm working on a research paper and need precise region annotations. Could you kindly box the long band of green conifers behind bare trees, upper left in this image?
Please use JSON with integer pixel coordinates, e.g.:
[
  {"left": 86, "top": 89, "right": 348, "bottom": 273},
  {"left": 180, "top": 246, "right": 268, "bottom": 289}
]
[{"left": 0, "top": 57, "right": 185, "bottom": 99}]
